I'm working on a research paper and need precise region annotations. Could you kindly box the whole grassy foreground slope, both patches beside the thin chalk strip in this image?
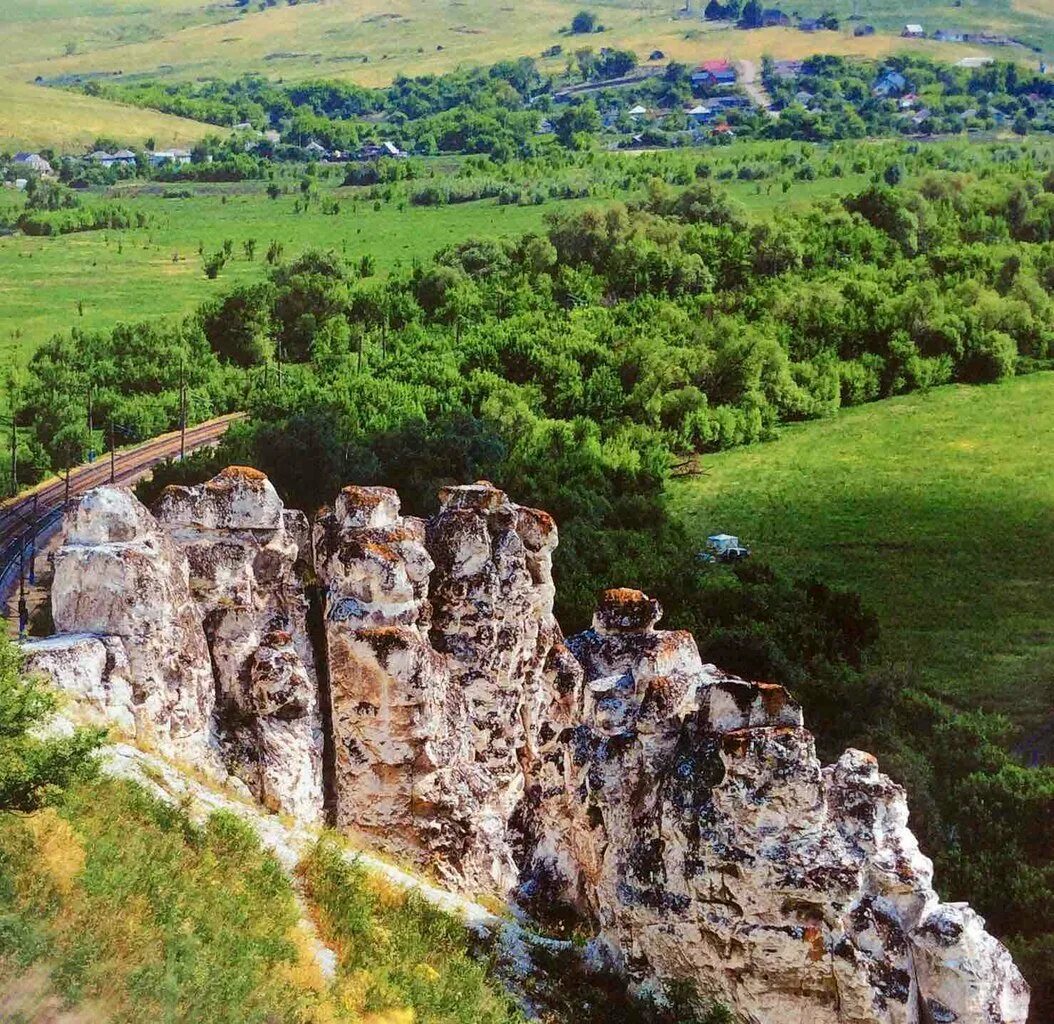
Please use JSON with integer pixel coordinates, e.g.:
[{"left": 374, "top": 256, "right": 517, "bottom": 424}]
[{"left": 0, "top": 781, "right": 523, "bottom": 1024}]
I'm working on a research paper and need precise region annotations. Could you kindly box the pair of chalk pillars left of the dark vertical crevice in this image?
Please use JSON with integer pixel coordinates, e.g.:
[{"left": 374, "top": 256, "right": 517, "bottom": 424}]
[{"left": 25, "top": 467, "right": 323, "bottom": 821}]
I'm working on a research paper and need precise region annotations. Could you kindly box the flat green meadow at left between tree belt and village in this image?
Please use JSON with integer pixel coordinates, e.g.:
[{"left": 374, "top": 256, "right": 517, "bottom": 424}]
[{"left": 0, "top": 185, "right": 569, "bottom": 375}]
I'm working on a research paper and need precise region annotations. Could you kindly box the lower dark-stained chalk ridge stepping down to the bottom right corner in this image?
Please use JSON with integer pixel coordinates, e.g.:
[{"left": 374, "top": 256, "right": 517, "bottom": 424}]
[{"left": 528, "top": 590, "right": 1028, "bottom": 1024}]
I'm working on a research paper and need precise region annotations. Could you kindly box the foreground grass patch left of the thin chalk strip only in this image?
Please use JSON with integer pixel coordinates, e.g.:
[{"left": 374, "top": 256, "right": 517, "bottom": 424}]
[{"left": 0, "top": 781, "right": 334, "bottom": 1024}]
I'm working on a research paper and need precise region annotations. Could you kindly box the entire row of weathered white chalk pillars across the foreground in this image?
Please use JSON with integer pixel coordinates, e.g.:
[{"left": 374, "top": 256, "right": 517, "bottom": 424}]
[{"left": 27, "top": 476, "right": 1028, "bottom": 1024}]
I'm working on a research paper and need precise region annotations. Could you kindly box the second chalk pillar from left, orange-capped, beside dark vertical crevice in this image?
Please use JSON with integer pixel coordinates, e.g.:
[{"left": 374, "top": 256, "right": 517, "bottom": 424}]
[{"left": 156, "top": 467, "right": 323, "bottom": 821}]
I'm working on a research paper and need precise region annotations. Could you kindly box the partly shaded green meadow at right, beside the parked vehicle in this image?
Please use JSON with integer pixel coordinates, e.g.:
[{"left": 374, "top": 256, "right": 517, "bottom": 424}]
[{"left": 671, "top": 373, "right": 1054, "bottom": 729}]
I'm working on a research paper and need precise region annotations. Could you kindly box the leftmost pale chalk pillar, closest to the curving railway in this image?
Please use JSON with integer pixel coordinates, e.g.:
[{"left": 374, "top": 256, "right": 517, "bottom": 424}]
[{"left": 41, "top": 487, "right": 218, "bottom": 770}]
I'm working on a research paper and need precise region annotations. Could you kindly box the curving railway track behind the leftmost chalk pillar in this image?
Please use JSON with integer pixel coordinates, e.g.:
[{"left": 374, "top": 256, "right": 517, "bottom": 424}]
[{"left": 0, "top": 413, "right": 245, "bottom": 615}]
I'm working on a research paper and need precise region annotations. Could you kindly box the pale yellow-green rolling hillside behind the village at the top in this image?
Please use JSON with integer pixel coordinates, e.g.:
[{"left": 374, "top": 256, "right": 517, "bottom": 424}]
[{"left": 0, "top": 0, "right": 1041, "bottom": 150}]
